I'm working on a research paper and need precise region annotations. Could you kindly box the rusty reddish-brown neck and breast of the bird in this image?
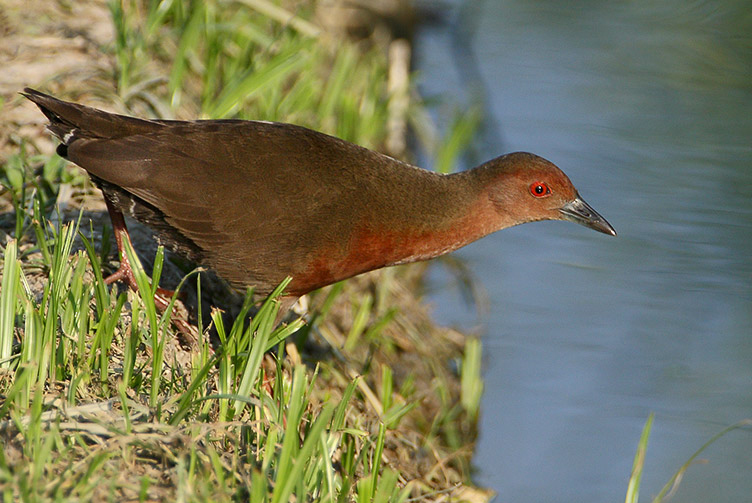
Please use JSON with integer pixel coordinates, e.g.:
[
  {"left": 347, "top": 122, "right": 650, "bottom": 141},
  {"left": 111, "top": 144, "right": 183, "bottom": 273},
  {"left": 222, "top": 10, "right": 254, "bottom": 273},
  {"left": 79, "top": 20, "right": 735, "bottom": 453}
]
[{"left": 294, "top": 170, "right": 515, "bottom": 296}]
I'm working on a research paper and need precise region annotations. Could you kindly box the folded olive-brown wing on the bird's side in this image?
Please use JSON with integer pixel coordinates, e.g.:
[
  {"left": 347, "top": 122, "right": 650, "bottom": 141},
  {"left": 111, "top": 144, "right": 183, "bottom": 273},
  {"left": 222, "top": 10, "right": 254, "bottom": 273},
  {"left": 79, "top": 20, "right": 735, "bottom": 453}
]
[{"left": 67, "top": 121, "right": 382, "bottom": 290}]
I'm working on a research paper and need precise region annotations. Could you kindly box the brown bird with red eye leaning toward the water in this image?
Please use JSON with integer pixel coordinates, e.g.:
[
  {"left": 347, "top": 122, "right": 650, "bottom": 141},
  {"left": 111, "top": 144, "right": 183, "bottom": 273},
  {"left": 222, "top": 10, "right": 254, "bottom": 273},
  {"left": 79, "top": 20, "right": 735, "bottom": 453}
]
[{"left": 21, "top": 87, "right": 616, "bottom": 314}]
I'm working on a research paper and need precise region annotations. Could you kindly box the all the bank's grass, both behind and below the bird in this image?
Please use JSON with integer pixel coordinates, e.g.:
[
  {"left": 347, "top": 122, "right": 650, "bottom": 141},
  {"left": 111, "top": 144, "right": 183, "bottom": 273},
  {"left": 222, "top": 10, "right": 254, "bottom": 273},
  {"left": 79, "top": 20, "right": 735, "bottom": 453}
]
[{"left": 0, "top": 0, "right": 482, "bottom": 502}]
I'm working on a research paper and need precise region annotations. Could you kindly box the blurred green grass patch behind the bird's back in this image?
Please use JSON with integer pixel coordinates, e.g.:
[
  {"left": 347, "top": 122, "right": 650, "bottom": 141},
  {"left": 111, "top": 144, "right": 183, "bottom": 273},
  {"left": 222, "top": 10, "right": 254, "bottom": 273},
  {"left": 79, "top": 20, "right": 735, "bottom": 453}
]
[{"left": 104, "top": 0, "right": 400, "bottom": 147}]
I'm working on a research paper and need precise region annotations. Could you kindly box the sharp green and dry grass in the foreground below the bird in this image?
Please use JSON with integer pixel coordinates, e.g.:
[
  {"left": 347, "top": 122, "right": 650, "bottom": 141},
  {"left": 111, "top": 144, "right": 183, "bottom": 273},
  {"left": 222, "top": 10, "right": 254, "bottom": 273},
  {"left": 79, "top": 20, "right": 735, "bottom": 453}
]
[{"left": 0, "top": 185, "right": 477, "bottom": 502}]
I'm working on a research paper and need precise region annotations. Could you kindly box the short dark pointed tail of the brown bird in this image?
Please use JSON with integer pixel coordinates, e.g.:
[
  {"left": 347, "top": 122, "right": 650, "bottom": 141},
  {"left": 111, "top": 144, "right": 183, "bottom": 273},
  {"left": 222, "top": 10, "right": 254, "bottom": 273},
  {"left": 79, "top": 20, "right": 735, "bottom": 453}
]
[{"left": 21, "top": 87, "right": 163, "bottom": 146}]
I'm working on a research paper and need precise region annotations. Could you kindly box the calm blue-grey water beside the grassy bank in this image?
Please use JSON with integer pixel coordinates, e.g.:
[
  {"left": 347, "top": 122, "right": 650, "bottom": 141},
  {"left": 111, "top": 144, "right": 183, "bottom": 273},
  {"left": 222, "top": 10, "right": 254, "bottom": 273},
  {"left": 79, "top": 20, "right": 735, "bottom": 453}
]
[{"left": 416, "top": 0, "right": 752, "bottom": 503}]
